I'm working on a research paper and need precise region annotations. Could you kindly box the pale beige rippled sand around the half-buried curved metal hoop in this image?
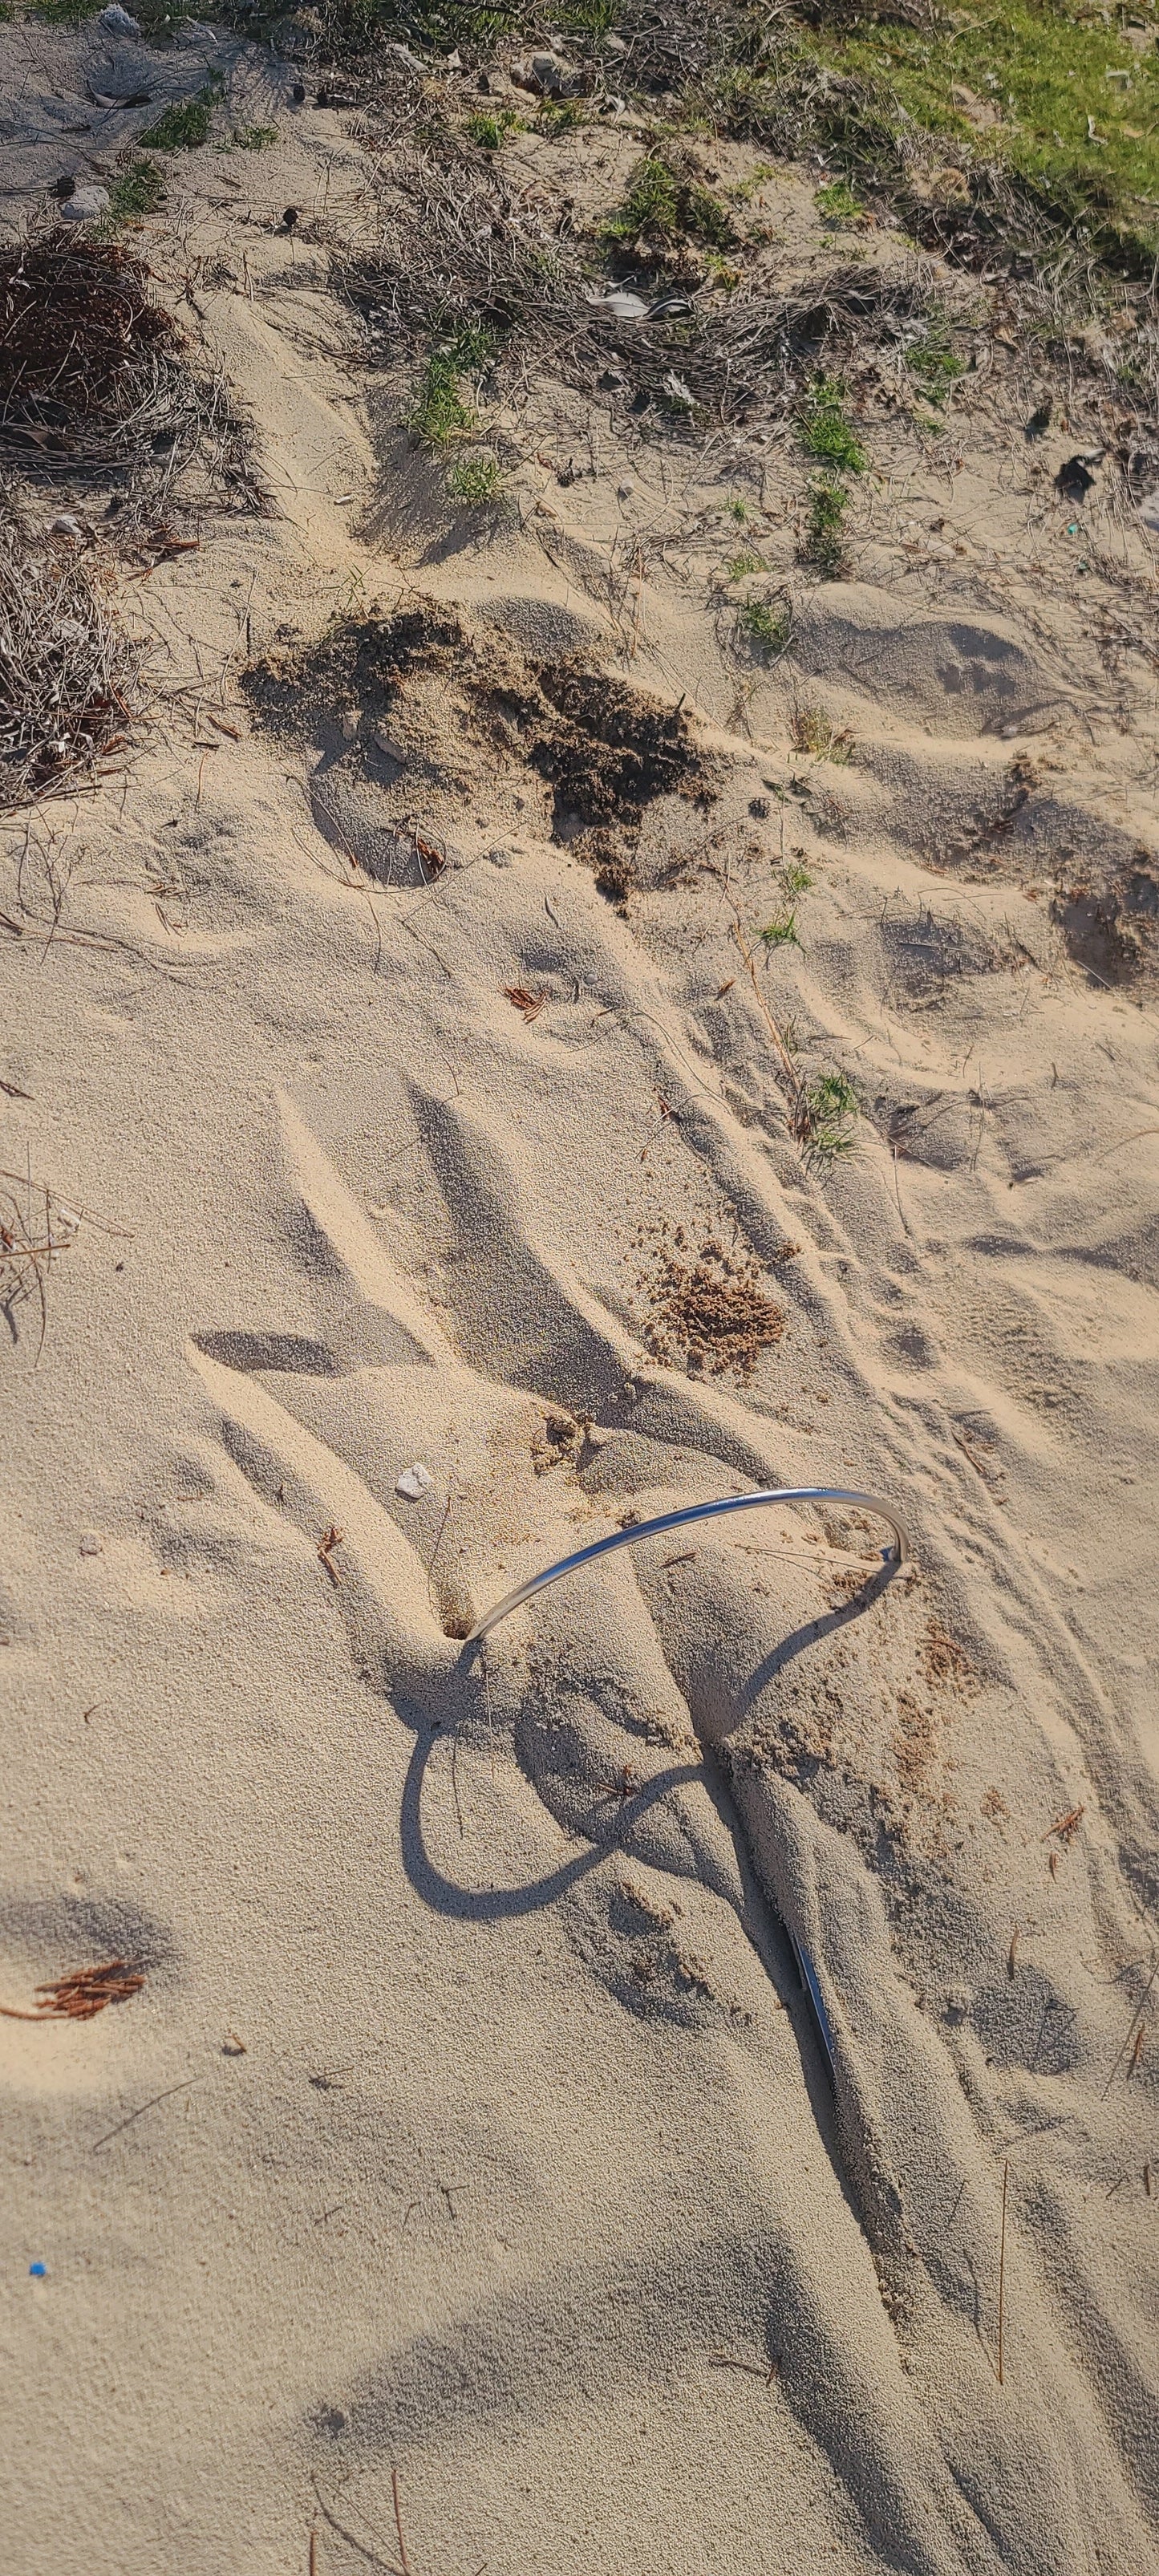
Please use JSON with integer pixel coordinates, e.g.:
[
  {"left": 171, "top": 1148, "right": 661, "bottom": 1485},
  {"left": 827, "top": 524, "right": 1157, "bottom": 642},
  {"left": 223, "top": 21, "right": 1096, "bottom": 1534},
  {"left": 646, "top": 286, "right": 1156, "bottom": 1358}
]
[{"left": 0, "top": 28, "right": 1159, "bottom": 2576}]
